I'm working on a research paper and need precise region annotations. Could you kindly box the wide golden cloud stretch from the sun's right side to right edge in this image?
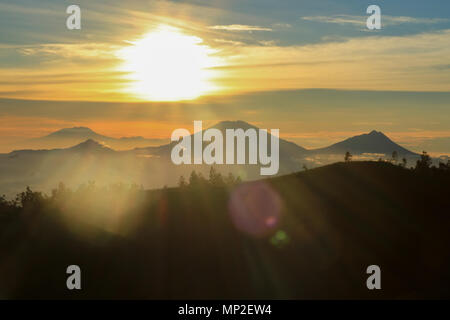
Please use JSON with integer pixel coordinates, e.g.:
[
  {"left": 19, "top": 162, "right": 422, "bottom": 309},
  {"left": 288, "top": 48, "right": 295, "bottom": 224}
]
[{"left": 213, "top": 30, "right": 450, "bottom": 91}]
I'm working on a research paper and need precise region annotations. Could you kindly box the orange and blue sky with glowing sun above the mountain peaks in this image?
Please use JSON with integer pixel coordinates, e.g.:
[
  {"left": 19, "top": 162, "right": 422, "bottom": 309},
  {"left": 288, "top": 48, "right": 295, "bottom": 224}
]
[{"left": 0, "top": 0, "right": 450, "bottom": 154}]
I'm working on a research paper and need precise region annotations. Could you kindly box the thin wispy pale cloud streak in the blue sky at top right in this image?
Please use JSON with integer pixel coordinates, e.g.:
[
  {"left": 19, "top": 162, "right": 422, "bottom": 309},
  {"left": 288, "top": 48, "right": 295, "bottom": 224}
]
[{"left": 301, "top": 14, "right": 450, "bottom": 26}]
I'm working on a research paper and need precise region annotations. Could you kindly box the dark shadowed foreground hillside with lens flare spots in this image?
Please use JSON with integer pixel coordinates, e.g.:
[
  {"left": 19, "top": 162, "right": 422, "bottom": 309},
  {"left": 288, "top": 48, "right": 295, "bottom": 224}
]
[{"left": 0, "top": 162, "right": 450, "bottom": 299}]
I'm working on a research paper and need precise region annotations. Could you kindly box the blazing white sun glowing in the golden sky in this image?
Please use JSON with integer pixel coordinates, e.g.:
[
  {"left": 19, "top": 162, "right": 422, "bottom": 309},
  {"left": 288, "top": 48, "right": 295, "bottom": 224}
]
[{"left": 119, "top": 26, "right": 220, "bottom": 101}]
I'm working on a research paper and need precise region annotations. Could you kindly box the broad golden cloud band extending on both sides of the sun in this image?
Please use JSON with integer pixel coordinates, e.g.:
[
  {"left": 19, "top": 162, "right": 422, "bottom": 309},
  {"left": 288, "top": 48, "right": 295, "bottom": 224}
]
[{"left": 4, "top": 29, "right": 450, "bottom": 101}]
